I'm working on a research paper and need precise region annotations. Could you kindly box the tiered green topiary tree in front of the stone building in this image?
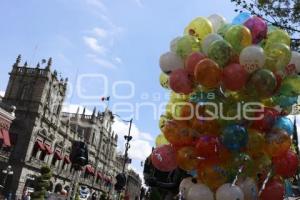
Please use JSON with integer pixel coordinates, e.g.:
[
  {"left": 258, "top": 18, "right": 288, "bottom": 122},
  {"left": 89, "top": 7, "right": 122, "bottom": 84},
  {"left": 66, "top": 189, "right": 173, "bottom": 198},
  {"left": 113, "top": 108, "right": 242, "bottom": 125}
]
[{"left": 31, "top": 166, "right": 52, "bottom": 200}]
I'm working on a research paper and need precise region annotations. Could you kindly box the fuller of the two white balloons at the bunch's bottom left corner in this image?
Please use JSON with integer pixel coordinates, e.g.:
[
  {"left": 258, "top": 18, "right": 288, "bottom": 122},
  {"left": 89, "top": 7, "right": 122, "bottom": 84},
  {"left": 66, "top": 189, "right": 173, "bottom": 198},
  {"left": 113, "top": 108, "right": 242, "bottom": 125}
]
[{"left": 186, "top": 184, "right": 214, "bottom": 200}]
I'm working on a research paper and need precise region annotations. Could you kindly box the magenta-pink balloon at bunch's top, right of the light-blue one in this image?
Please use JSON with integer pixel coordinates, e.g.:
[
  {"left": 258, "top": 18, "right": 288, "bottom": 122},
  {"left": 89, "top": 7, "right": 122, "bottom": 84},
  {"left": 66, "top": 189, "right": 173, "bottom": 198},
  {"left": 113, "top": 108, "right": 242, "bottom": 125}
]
[{"left": 244, "top": 16, "right": 268, "bottom": 44}]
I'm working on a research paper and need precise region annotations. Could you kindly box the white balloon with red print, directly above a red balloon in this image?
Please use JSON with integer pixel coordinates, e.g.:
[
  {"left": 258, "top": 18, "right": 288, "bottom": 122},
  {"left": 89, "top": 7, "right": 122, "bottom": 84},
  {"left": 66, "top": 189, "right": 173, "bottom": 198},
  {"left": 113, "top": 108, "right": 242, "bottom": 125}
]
[{"left": 240, "top": 45, "right": 266, "bottom": 73}]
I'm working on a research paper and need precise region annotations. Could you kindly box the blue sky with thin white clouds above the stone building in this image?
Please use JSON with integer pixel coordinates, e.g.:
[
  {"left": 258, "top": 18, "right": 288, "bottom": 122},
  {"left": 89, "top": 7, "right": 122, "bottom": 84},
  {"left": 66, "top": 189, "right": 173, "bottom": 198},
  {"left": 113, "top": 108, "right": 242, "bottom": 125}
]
[{"left": 0, "top": 0, "right": 235, "bottom": 180}]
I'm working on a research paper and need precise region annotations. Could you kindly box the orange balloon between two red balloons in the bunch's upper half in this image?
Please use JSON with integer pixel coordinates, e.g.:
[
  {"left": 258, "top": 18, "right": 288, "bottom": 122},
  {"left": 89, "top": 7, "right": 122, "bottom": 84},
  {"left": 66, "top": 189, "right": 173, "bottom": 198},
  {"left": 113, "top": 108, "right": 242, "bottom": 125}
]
[{"left": 194, "top": 58, "right": 222, "bottom": 88}]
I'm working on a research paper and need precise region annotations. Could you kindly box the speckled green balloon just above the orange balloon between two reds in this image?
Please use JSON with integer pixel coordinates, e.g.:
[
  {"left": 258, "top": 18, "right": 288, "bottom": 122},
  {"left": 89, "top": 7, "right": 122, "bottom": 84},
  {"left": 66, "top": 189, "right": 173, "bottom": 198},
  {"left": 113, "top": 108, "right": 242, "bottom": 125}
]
[{"left": 207, "top": 40, "right": 232, "bottom": 67}]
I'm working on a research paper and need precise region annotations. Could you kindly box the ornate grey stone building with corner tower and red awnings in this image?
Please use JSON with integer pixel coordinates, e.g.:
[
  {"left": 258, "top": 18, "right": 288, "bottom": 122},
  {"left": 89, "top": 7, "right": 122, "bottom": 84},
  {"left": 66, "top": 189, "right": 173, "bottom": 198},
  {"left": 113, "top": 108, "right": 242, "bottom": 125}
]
[{"left": 0, "top": 56, "right": 124, "bottom": 198}]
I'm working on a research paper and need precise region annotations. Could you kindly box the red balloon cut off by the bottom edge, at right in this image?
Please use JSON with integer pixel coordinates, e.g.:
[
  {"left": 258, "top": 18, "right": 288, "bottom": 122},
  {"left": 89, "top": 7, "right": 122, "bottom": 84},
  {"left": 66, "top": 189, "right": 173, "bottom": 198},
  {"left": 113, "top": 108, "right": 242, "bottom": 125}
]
[{"left": 260, "top": 179, "right": 284, "bottom": 200}]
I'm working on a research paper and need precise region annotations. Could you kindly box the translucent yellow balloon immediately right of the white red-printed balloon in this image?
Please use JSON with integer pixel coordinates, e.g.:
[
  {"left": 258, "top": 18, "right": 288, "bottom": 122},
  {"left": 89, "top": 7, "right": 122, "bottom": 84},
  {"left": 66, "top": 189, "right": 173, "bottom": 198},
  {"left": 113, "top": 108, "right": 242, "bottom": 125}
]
[{"left": 265, "top": 43, "right": 291, "bottom": 72}]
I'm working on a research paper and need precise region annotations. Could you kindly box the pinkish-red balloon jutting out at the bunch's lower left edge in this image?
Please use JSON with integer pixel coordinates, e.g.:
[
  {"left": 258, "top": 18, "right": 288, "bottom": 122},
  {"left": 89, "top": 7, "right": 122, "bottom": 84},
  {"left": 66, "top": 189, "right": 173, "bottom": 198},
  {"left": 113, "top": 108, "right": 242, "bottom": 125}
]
[{"left": 151, "top": 145, "right": 177, "bottom": 172}]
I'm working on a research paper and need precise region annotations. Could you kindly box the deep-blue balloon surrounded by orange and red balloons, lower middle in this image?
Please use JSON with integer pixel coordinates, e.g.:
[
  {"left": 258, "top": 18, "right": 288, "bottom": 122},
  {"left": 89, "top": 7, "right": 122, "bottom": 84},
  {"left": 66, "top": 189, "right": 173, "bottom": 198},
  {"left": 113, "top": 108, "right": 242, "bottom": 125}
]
[{"left": 221, "top": 124, "right": 248, "bottom": 151}]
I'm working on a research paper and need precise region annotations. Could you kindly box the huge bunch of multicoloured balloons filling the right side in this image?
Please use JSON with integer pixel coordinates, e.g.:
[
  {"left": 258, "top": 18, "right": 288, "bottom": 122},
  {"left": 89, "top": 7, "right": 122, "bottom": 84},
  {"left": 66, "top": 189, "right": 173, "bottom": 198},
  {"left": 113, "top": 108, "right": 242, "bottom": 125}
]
[{"left": 151, "top": 13, "right": 300, "bottom": 200}]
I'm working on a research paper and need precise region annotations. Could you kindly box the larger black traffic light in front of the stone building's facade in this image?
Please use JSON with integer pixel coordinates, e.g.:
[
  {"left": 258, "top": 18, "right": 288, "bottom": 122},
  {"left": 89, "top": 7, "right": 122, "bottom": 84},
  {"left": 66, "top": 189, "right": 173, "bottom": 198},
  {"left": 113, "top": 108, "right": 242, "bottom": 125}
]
[{"left": 70, "top": 141, "right": 89, "bottom": 169}]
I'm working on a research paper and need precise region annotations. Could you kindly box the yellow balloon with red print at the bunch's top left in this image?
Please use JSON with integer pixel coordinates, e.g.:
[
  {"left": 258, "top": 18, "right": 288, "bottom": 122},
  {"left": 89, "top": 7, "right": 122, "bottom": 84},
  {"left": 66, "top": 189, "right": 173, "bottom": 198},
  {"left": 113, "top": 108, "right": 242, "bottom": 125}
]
[{"left": 184, "top": 17, "right": 213, "bottom": 42}]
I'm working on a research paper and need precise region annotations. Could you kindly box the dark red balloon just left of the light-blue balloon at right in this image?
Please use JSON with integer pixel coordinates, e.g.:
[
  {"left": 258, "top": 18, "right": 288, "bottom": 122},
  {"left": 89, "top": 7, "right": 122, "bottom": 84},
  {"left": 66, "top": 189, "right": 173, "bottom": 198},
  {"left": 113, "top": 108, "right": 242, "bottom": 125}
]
[{"left": 252, "top": 107, "right": 280, "bottom": 133}]
